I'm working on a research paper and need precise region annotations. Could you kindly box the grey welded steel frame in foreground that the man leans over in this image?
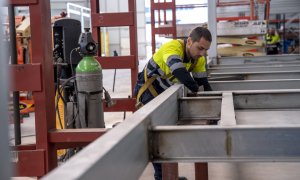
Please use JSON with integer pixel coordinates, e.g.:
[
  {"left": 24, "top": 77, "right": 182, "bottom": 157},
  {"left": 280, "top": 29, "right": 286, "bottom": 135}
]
[{"left": 43, "top": 85, "right": 300, "bottom": 180}]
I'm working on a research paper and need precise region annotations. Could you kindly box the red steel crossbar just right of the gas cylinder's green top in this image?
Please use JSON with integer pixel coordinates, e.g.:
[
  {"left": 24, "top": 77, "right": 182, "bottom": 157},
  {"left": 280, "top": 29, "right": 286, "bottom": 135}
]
[{"left": 95, "top": 56, "right": 137, "bottom": 69}]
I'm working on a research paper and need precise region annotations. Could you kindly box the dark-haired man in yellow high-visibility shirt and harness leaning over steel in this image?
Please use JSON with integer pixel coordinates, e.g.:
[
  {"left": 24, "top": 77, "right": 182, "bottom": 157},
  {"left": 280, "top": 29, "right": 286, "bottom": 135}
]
[{"left": 134, "top": 27, "right": 212, "bottom": 180}]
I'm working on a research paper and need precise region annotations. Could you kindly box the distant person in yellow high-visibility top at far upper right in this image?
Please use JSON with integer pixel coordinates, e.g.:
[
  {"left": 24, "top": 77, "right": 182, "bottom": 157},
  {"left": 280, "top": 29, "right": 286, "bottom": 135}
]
[{"left": 266, "top": 28, "right": 280, "bottom": 55}]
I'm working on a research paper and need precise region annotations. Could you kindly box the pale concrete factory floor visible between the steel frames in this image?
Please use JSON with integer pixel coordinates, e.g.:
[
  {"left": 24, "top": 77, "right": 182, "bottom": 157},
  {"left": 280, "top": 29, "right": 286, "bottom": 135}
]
[{"left": 9, "top": 60, "right": 300, "bottom": 180}]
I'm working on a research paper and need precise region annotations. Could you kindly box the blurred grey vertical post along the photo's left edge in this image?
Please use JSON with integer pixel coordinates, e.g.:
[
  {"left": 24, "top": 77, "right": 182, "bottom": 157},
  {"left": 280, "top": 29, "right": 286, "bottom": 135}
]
[{"left": 0, "top": 0, "right": 11, "bottom": 179}]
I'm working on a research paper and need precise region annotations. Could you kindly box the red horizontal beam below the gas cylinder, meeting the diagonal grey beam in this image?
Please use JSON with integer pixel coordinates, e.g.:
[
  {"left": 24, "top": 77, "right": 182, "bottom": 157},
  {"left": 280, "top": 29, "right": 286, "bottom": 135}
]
[{"left": 49, "top": 128, "right": 107, "bottom": 149}]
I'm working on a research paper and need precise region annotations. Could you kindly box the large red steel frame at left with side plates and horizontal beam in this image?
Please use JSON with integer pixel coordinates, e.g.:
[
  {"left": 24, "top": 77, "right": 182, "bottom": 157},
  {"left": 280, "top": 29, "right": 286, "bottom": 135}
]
[{"left": 8, "top": 0, "right": 106, "bottom": 177}]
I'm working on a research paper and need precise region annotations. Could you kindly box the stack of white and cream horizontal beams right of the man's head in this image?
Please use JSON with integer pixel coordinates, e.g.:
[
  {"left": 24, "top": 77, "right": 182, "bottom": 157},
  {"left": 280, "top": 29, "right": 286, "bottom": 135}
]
[{"left": 217, "top": 20, "right": 267, "bottom": 56}]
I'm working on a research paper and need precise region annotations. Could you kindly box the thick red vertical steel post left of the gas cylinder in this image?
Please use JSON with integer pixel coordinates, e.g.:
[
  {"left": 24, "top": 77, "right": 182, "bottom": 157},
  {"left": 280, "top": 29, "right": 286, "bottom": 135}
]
[{"left": 29, "top": 0, "right": 57, "bottom": 173}]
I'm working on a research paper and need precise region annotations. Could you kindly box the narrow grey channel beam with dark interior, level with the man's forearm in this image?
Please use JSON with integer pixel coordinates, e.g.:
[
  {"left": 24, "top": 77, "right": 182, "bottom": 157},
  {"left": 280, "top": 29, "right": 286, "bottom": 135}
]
[{"left": 209, "top": 71, "right": 300, "bottom": 81}]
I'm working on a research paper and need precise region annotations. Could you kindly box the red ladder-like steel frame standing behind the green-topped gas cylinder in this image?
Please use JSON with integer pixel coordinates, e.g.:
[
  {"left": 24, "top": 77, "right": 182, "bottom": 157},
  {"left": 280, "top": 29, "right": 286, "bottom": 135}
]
[{"left": 91, "top": 0, "right": 138, "bottom": 112}]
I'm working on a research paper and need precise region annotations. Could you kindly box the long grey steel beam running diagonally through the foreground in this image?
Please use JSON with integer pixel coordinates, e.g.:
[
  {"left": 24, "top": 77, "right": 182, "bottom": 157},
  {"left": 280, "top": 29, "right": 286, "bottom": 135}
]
[{"left": 42, "top": 85, "right": 183, "bottom": 180}]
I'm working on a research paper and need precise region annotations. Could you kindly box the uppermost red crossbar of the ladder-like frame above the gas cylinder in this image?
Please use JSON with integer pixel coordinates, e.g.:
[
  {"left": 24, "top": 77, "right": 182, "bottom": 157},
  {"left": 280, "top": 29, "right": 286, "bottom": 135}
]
[{"left": 92, "top": 12, "right": 134, "bottom": 27}]
